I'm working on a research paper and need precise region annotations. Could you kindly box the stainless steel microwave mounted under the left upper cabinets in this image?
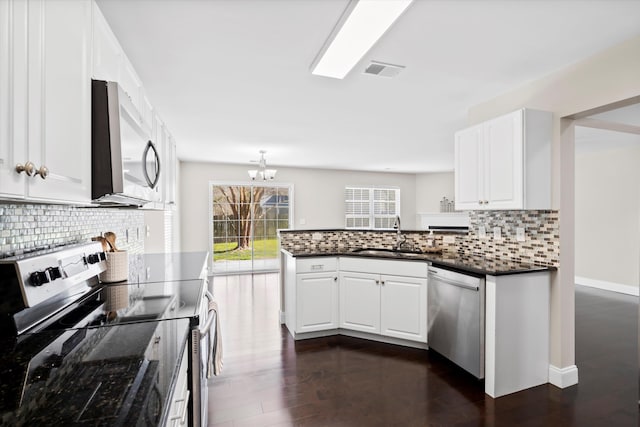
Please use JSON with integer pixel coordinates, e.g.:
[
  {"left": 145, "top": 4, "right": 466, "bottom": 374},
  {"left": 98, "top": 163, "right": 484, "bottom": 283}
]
[{"left": 91, "top": 80, "right": 160, "bottom": 206}]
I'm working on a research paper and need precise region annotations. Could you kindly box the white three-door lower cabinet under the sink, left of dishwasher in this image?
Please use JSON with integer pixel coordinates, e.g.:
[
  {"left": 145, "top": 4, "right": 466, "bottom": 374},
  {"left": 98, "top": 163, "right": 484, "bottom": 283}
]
[{"left": 282, "top": 254, "right": 427, "bottom": 344}]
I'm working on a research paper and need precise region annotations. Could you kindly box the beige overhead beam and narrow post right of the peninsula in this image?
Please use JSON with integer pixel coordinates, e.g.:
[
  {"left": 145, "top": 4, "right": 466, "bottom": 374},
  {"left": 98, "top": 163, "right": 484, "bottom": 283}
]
[{"left": 468, "top": 37, "right": 640, "bottom": 378}]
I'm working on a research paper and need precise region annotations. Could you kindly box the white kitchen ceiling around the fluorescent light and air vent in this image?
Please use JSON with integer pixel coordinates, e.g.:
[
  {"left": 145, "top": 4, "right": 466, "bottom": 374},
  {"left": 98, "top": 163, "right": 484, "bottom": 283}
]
[{"left": 97, "top": 0, "right": 640, "bottom": 173}]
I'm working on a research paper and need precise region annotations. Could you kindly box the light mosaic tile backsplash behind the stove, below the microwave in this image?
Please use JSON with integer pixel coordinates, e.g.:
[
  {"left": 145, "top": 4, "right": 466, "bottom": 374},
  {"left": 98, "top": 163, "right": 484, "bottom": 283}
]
[{"left": 0, "top": 203, "right": 144, "bottom": 258}]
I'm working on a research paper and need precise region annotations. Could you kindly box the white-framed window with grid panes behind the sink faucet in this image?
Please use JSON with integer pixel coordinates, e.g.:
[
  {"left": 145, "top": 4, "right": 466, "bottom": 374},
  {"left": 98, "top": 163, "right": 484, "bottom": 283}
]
[{"left": 344, "top": 187, "right": 400, "bottom": 229}]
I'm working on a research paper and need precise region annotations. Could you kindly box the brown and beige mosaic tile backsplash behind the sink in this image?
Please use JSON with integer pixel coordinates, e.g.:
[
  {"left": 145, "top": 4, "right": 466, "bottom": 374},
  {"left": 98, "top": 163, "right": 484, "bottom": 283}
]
[{"left": 280, "top": 210, "right": 560, "bottom": 267}]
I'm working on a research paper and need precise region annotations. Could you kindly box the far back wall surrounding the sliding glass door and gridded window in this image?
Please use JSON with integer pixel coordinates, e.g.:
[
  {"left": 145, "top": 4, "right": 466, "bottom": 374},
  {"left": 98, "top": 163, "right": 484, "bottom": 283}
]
[{"left": 178, "top": 162, "right": 416, "bottom": 251}]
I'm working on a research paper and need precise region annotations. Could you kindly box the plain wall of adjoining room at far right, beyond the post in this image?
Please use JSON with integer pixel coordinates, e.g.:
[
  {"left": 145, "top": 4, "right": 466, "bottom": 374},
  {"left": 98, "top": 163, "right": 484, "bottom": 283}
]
[{"left": 575, "top": 127, "right": 640, "bottom": 288}]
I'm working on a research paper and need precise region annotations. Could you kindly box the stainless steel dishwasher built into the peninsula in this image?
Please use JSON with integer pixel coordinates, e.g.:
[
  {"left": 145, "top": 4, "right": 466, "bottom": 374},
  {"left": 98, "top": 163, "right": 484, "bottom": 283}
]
[{"left": 427, "top": 266, "right": 485, "bottom": 378}]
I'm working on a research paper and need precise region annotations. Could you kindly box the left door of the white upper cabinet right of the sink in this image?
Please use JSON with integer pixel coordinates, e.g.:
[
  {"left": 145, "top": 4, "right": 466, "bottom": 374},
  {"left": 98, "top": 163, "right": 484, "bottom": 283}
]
[{"left": 454, "top": 126, "right": 484, "bottom": 210}]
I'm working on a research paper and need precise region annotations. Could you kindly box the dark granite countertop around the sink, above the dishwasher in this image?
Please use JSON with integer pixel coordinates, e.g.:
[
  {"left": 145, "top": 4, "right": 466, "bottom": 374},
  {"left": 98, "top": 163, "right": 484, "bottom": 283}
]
[{"left": 282, "top": 249, "right": 556, "bottom": 276}]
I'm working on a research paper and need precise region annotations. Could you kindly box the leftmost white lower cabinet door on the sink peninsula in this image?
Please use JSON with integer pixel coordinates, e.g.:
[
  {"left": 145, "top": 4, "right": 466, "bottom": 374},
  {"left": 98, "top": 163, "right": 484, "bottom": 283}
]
[{"left": 296, "top": 272, "right": 338, "bottom": 333}]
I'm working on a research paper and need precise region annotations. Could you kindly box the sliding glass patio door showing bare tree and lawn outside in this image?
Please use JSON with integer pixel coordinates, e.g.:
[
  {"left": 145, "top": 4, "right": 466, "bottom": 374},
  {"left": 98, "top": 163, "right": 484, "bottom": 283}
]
[{"left": 209, "top": 182, "right": 293, "bottom": 275}]
